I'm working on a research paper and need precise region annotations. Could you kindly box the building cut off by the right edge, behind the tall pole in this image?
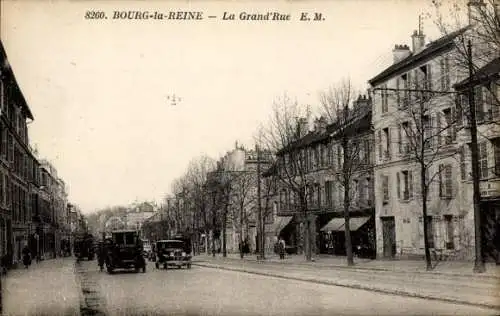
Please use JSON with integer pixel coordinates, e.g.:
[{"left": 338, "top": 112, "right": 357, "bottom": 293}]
[{"left": 455, "top": 58, "right": 500, "bottom": 262}]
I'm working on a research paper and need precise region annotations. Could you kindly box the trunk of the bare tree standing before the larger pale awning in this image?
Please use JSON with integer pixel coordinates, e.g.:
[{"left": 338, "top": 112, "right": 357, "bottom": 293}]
[{"left": 342, "top": 136, "right": 354, "bottom": 266}]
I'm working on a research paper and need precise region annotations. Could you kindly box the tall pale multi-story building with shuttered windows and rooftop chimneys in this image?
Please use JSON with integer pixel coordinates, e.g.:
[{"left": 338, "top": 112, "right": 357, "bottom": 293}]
[{"left": 369, "top": 0, "right": 496, "bottom": 258}]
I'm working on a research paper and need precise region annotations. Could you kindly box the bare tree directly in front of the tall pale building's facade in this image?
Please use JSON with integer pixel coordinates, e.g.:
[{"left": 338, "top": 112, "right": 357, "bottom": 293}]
[{"left": 378, "top": 76, "right": 458, "bottom": 270}]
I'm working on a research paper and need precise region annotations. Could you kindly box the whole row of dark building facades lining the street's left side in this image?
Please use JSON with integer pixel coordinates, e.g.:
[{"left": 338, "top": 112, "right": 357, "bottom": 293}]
[{"left": 0, "top": 42, "right": 75, "bottom": 265}]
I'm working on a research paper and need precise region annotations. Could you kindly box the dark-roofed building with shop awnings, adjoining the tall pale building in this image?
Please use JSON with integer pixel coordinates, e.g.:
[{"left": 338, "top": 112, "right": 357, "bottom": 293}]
[{"left": 266, "top": 96, "right": 374, "bottom": 254}]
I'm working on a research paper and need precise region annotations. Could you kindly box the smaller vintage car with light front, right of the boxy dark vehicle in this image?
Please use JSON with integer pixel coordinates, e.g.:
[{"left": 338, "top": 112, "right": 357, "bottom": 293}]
[{"left": 155, "top": 239, "right": 191, "bottom": 269}]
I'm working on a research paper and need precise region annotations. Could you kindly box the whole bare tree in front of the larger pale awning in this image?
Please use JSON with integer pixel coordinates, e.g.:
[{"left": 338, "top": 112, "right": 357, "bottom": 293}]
[{"left": 320, "top": 79, "right": 373, "bottom": 266}]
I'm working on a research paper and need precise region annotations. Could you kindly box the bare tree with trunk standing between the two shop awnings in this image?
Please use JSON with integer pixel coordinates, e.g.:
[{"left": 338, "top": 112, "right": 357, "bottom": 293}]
[{"left": 261, "top": 95, "right": 312, "bottom": 261}]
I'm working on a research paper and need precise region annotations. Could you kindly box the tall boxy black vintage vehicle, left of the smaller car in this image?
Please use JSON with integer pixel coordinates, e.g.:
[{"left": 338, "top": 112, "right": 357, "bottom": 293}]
[{"left": 105, "top": 230, "right": 146, "bottom": 273}]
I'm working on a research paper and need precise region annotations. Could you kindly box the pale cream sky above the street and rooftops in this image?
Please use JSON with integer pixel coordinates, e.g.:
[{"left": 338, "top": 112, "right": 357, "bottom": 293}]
[{"left": 0, "top": 0, "right": 454, "bottom": 213}]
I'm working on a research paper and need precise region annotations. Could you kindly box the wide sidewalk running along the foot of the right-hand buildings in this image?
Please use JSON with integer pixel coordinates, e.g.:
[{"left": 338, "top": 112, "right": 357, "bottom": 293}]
[{"left": 193, "top": 254, "right": 500, "bottom": 310}]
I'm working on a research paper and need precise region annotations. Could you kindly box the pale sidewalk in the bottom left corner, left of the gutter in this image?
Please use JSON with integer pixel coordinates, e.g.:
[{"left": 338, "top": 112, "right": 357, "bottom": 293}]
[{"left": 2, "top": 257, "right": 80, "bottom": 315}]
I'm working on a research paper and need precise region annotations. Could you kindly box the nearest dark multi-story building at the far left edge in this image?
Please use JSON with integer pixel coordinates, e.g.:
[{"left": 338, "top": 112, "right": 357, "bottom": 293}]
[{"left": 0, "top": 43, "right": 33, "bottom": 263}]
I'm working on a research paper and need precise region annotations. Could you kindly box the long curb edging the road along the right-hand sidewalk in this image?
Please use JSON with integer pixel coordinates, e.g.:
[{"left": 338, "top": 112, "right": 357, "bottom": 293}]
[{"left": 193, "top": 262, "right": 500, "bottom": 310}]
